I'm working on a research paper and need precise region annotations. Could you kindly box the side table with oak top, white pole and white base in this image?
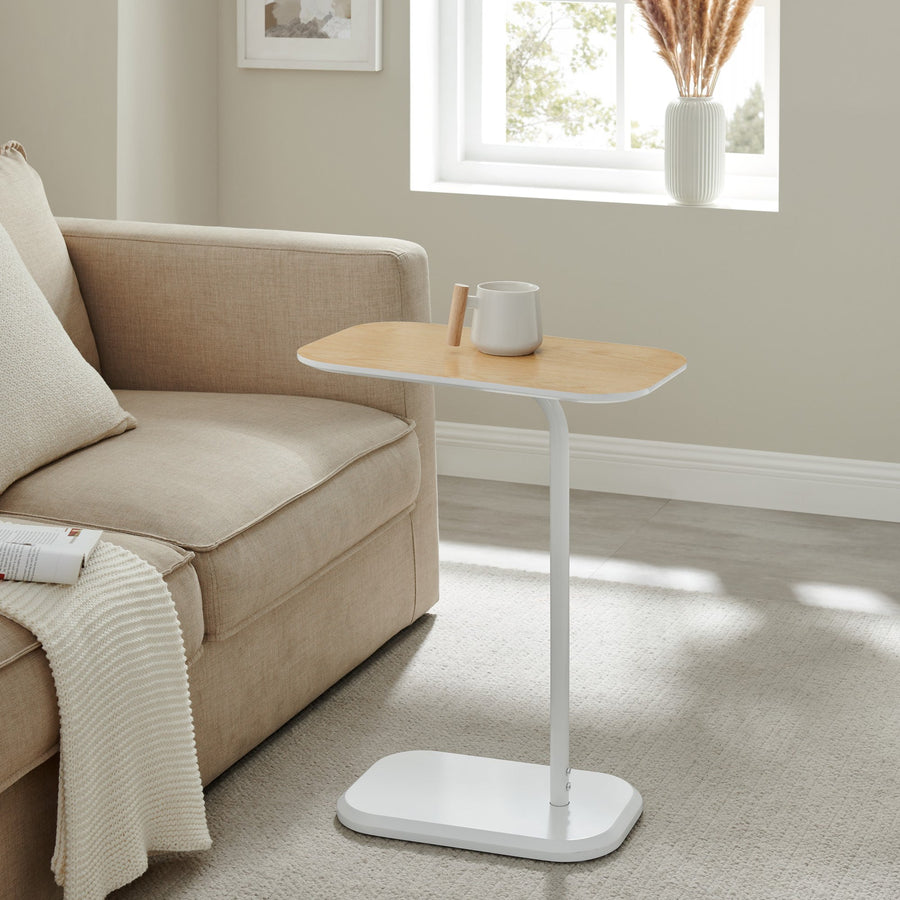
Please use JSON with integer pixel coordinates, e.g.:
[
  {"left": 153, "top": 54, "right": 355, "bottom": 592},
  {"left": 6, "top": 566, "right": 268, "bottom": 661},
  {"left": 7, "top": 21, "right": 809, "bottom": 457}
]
[{"left": 297, "top": 322, "right": 686, "bottom": 862}]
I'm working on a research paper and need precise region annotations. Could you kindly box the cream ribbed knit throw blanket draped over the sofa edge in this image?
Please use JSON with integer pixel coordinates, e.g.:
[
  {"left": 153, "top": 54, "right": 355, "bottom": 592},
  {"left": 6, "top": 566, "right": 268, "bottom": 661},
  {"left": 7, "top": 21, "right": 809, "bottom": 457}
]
[{"left": 0, "top": 541, "right": 211, "bottom": 900}]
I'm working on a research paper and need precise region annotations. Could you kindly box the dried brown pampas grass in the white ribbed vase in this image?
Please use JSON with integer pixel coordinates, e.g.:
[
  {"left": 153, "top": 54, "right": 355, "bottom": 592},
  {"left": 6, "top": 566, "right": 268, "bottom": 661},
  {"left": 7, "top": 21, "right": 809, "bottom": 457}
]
[{"left": 634, "top": 0, "right": 753, "bottom": 97}]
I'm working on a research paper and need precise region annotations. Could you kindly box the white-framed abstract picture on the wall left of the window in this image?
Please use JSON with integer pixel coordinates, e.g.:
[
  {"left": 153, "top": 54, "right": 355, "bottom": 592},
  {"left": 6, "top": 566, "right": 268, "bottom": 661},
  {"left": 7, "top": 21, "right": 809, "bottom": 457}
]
[{"left": 237, "top": 0, "right": 382, "bottom": 72}]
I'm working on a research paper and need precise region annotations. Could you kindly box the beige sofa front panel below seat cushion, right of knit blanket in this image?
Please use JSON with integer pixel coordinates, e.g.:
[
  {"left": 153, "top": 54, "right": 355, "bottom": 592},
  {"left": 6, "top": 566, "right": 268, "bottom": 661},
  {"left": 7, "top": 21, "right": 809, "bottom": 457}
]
[{"left": 190, "top": 513, "right": 418, "bottom": 784}]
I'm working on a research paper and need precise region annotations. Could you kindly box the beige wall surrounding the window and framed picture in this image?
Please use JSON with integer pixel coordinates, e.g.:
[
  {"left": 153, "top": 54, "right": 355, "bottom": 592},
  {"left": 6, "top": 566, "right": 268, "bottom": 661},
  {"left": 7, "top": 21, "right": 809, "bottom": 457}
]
[{"left": 219, "top": 0, "right": 900, "bottom": 462}]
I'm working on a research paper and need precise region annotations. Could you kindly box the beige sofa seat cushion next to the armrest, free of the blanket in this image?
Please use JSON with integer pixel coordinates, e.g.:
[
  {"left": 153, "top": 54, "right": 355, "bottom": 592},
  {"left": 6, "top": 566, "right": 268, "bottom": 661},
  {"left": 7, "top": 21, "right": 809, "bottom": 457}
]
[{"left": 0, "top": 391, "right": 419, "bottom": 639}]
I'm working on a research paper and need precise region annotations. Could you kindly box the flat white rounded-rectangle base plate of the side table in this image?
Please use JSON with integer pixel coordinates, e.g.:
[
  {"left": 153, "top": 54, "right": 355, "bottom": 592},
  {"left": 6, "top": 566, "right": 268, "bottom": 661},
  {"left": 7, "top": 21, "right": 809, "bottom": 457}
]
[{"left": 338, "top": 750, "right": 643, "bottom": 862}]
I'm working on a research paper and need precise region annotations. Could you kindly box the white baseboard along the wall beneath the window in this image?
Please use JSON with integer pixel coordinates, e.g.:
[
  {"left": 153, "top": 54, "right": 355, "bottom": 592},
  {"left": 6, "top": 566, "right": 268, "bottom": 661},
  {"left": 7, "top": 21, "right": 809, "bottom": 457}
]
[{"left": 437, "top": 422, "right": 900, "bottom": 522}]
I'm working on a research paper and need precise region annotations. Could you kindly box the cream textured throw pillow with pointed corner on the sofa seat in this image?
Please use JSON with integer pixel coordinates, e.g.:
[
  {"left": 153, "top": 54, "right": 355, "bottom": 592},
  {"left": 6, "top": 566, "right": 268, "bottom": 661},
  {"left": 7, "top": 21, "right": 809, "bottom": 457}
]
[{"left": 0, "top": 225, "right": 135, "bottom": 493}]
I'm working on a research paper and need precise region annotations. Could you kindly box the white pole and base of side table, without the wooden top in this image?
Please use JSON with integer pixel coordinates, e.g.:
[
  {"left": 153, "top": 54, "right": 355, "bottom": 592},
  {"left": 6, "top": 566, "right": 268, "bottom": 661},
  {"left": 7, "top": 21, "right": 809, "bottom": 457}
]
[{"left": 338, "top": 397, "right": 643, "bottom": 862}]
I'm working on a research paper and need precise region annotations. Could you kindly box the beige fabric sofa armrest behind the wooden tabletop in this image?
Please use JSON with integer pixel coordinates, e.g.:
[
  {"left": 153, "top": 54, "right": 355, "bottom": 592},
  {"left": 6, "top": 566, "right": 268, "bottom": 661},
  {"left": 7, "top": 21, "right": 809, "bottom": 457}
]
[{"left": 59, "top": 219, "right": 429, "bottom": 415}]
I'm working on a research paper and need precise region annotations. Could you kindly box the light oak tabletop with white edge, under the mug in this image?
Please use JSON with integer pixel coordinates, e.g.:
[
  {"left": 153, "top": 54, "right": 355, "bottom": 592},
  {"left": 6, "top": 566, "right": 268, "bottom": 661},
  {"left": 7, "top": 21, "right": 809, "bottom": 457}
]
[{"left": 297, "top": 322, "right": 686, "bottom": 403}]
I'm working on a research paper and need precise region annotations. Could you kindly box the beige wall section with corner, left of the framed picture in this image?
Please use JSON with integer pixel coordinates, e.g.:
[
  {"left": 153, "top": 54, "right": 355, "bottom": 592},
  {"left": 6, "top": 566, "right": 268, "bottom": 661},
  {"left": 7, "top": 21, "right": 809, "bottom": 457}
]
[{"left": 0, "top": 0, "right": 218, "bottom": 223}]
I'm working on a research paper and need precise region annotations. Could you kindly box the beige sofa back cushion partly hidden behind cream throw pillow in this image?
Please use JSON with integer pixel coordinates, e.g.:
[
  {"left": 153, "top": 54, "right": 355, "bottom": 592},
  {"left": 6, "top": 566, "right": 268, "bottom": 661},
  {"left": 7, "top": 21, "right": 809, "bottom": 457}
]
[{"left": 0, "top": 141, "right": 100, "bottom": 369}]
